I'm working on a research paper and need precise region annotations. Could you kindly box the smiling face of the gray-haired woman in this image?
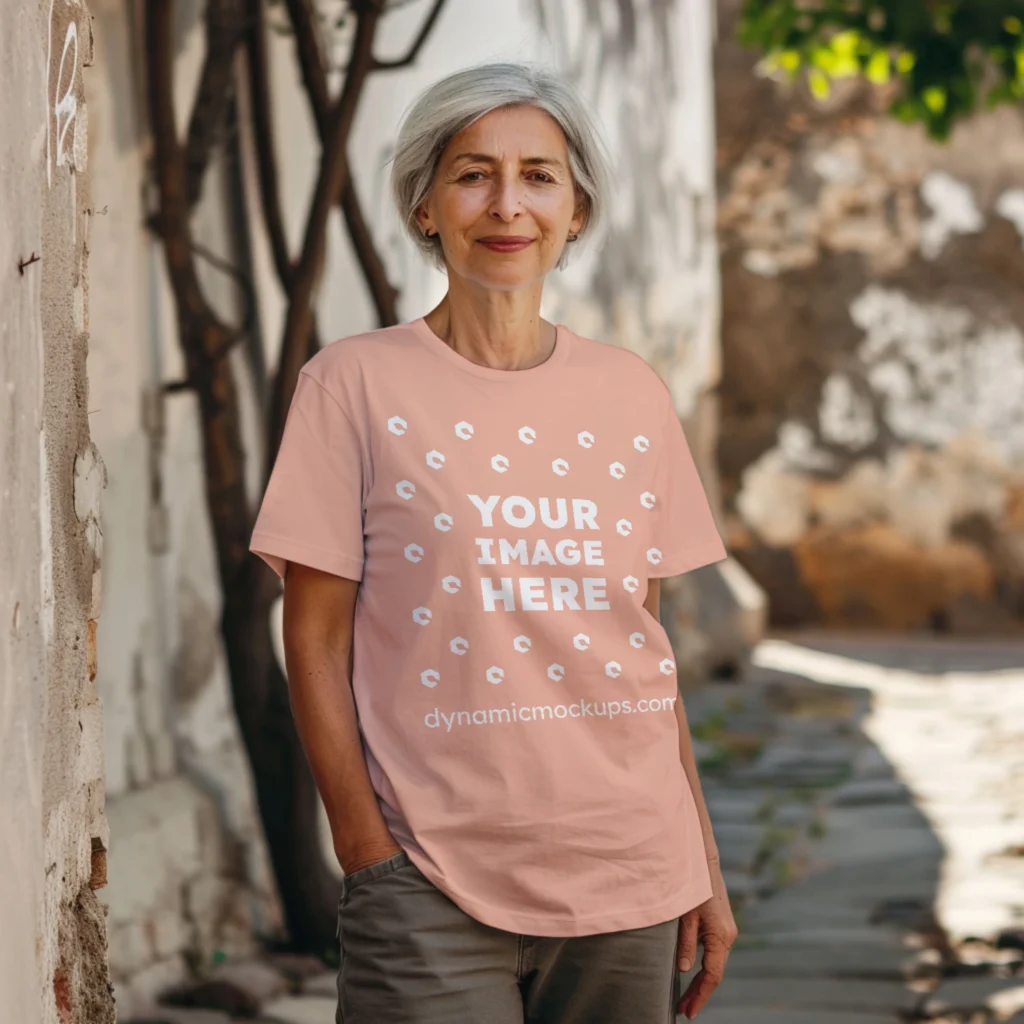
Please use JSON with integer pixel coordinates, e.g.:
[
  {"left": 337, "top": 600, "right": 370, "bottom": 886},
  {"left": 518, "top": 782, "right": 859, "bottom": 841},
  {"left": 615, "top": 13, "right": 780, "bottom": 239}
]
[{"left": 418, "top": 106, "right": 584, "bottom": 291}]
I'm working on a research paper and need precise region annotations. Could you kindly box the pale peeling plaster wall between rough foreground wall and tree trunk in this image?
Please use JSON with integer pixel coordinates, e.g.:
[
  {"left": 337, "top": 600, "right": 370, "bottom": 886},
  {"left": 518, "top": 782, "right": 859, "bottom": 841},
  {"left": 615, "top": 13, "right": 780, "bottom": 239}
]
[{"left": 87, "top": 0, "right": 281, "bottom": 1017}]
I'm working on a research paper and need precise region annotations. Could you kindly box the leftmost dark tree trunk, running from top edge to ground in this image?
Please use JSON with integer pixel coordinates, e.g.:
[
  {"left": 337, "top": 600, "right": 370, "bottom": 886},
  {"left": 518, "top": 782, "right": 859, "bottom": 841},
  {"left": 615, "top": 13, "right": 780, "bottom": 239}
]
[{"left": 146, "top": 0, "right": 338, "bottom": 956}]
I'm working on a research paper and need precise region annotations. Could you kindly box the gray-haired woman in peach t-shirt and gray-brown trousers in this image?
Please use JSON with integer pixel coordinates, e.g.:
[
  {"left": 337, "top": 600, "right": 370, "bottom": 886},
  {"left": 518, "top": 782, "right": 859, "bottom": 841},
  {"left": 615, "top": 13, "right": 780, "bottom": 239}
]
[{"left": 252, "top": 65, "right": 736, "bottom": 1024}]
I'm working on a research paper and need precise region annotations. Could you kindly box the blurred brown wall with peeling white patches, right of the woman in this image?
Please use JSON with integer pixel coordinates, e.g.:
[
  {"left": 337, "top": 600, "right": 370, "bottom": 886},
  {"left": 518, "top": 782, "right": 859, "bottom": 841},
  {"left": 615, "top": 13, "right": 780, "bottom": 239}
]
[{"left": 716, "top": 0, "right": 1024, "bottom": 632}]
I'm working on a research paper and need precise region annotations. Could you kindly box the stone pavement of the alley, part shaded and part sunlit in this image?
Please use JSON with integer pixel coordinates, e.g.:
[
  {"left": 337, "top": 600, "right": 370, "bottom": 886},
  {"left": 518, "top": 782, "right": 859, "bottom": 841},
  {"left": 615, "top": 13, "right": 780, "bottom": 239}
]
[{"left": 123, "top": 634, "right": 1024, "bottom": 1024}]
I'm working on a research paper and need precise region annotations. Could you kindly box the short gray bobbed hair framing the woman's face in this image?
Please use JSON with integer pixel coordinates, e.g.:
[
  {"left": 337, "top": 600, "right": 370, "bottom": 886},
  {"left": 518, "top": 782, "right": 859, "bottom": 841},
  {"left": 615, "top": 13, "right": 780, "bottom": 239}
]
[{"left": 391, "top": 63, "right": 611, "bottom": 267}]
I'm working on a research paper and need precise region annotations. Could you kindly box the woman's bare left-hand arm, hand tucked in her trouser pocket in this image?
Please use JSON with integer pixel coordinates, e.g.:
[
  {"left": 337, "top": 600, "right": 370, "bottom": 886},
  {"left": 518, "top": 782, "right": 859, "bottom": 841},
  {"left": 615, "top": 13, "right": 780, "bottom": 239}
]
[{"left": 284, "top": 562, "right": 401, "bottom": 874}]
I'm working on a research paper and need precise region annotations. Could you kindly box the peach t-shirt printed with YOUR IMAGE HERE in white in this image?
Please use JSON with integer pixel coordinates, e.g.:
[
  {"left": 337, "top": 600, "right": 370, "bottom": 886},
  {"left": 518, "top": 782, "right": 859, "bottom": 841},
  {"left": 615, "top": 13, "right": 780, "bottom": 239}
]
[{"left": 251, "top": 319, "right": 725, "bottom": 936}]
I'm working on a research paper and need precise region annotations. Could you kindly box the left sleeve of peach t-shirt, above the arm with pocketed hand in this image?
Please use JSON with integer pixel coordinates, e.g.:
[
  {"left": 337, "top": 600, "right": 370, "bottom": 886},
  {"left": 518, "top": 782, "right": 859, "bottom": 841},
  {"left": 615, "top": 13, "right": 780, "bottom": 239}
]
[{"left": 249, "top": 373, "right": 366, "bottom": 580}]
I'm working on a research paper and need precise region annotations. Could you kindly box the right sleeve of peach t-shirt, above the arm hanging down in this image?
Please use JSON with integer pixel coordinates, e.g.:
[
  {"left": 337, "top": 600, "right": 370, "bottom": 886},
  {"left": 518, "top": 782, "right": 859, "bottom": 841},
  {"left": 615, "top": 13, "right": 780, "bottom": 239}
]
[{"left": 648, "top": 403, "right": 727, "bottom": 579}]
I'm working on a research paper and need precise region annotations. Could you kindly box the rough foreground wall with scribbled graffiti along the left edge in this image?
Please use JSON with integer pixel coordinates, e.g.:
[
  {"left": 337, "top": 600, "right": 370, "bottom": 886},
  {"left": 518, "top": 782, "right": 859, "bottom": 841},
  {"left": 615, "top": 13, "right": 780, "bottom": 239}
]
[{"left": 0, "top": 0, "right": 114, "bottom": 1024}]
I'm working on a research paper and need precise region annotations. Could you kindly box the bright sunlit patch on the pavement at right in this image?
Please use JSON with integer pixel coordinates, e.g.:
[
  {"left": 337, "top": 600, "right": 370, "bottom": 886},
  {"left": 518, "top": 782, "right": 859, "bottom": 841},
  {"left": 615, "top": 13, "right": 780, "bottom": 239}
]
[{"left": 753, "top": 638, "right": 1024, "bottom": 938}]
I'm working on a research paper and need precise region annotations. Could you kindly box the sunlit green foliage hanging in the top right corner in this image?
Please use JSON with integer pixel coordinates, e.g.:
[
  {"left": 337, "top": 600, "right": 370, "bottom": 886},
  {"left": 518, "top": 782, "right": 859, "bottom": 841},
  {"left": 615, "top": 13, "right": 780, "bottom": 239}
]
[{"left": 738, "top": 0, "right": 1024, "bottom": 139}]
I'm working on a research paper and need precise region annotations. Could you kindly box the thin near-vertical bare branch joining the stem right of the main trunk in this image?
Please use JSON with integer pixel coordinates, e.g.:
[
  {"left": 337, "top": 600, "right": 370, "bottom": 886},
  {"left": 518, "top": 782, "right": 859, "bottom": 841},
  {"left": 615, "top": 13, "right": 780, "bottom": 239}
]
[{"left": 246, "top": 0, "right": 294, "bottom": 292}]
